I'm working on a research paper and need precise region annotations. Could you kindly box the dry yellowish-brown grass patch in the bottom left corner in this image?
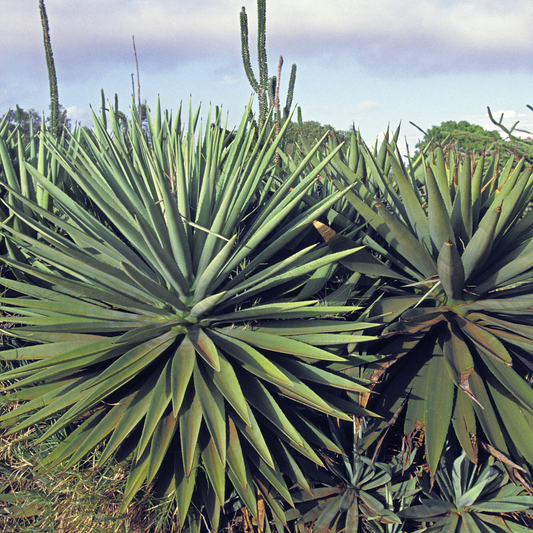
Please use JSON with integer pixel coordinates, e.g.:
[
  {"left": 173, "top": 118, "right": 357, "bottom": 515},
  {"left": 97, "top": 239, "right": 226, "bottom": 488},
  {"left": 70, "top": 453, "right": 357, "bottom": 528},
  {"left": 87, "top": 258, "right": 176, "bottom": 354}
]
[{"left": 0, "top": 428, "right": 181, "bottom": 533}]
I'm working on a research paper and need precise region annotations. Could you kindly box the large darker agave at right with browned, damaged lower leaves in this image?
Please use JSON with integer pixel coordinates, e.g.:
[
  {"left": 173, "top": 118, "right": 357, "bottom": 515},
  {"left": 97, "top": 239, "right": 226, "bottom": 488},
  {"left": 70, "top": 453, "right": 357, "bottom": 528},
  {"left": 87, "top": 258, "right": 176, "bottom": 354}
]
[{"left": 312, "top": 135, "right": 533, "bottom": 475}]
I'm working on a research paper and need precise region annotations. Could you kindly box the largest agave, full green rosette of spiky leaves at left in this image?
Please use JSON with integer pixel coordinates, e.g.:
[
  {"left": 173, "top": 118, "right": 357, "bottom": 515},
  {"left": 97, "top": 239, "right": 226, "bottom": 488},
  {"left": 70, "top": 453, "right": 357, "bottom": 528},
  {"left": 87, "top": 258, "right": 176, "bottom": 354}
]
[{"left": 0, "top": 98, "right": 378, "bottom": 530}]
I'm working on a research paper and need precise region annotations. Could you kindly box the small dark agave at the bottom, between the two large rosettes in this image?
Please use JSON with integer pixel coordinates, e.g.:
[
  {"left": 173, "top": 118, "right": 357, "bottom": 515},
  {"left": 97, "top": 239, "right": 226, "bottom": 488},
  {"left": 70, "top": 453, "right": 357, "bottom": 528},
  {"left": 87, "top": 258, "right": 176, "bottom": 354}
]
[{"left": 286, "top": 419, "right": 419, "bottom": 533}]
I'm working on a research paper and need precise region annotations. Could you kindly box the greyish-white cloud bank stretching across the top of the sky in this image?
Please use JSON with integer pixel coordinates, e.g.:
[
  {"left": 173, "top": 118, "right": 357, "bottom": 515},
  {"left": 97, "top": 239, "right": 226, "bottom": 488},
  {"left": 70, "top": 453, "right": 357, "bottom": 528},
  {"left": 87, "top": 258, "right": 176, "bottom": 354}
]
[{"left": 4, "top": 0, "right": 533, "bottom": 80}]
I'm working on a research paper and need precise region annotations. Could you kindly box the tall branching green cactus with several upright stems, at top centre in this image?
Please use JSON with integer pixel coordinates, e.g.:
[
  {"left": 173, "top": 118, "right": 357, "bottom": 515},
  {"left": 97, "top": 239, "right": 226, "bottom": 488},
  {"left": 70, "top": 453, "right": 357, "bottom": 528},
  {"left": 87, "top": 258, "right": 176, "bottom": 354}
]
[{"left": 240, "top": 0, "right": 296, "bottom": 131}]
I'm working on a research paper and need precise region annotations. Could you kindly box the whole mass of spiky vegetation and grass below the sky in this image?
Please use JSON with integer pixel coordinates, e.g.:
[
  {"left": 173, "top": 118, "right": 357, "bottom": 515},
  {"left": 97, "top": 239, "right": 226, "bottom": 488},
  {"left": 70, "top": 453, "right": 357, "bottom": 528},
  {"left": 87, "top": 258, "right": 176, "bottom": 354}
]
[{"left": 0, "top": 0, "right": 533, "bottom": 533}]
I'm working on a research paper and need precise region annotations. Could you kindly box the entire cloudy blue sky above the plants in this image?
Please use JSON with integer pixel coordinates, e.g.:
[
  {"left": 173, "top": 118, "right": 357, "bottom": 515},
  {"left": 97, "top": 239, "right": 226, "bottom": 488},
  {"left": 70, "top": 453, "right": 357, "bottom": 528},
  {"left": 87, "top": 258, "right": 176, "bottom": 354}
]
[{"left": 0, "top": 0, "right": 533, "bottom": 145}]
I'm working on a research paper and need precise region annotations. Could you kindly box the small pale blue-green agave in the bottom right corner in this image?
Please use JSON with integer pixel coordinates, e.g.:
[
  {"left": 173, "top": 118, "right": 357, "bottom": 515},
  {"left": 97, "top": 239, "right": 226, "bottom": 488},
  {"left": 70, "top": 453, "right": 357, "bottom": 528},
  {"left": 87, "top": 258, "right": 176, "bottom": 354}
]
[{"left": 399, "top": 450, "right": 533, "bottom": 533}]
